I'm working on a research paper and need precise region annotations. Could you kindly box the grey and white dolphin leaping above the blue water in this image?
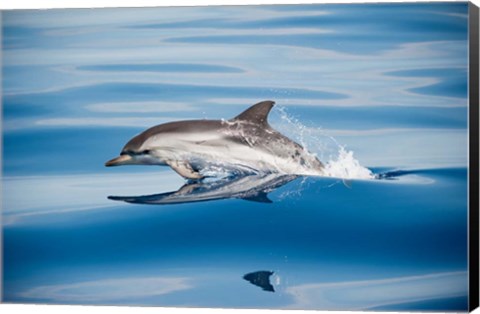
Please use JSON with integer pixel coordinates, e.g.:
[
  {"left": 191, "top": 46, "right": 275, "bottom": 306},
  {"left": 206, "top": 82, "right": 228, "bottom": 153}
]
[{"left": 105, "top": 101, "right": 323, "bottom": 180}]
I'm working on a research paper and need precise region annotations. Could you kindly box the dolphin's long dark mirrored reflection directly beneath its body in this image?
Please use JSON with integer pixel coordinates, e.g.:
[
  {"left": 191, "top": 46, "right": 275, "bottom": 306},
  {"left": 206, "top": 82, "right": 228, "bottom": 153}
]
[{"left": 108, "top": 174, "right": 298, "bottom": 205}]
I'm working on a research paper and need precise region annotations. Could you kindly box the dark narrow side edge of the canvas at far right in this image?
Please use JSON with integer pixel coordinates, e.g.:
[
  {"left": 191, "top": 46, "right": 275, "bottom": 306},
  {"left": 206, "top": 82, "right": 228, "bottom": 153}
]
[{"left": 468, "top": 2, "right": 479, "bottom": 311}]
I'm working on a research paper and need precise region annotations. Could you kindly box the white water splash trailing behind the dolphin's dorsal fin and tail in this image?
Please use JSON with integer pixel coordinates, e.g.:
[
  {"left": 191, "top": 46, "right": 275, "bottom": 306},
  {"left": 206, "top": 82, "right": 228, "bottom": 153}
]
[{"left": 275, "top": 106, "right": 375, "bottom": 179}]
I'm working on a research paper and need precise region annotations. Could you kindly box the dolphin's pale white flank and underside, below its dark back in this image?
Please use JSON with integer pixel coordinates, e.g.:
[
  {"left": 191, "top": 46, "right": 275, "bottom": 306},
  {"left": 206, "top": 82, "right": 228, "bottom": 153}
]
[{"left": 144, "top": 131, "right": 322, "bottom": 176}]
